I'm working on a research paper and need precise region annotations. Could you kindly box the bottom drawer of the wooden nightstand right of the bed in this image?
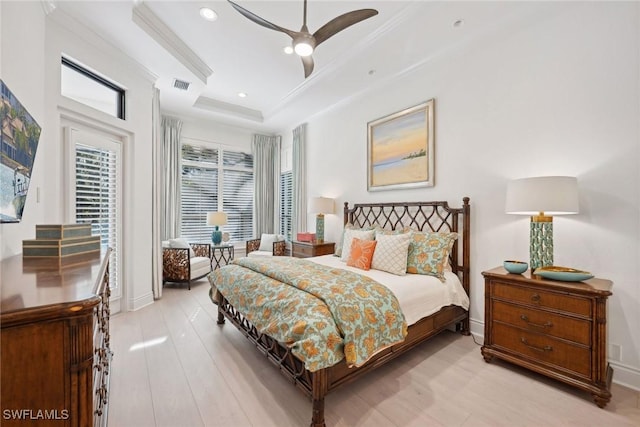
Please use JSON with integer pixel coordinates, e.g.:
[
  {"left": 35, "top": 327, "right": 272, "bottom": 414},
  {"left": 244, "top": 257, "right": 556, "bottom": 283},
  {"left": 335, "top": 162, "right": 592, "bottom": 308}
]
[{"left": 492, "top": 321, "right": 591, "bottom": 378}]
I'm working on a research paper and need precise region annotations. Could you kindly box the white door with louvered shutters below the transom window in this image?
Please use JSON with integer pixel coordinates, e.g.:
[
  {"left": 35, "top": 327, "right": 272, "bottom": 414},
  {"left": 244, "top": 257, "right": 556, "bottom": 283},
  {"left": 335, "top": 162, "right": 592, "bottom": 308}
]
[{"left": 70, "top": 129, "right": 122, "bottom": 297}]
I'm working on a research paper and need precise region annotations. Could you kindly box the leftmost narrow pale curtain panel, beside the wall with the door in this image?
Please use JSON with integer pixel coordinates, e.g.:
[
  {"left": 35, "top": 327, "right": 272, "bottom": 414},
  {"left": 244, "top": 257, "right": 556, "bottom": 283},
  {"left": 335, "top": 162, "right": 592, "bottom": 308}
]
[{"left": 151, "top": 88, "right": 162, "bottom": 299}]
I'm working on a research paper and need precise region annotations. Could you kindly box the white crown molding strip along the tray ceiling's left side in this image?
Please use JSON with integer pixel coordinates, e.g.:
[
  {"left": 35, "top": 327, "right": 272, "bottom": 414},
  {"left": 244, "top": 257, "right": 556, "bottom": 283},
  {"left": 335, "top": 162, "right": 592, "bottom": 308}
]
[{"left": 131, "top": 2, "right": 213, "bottom": 84}]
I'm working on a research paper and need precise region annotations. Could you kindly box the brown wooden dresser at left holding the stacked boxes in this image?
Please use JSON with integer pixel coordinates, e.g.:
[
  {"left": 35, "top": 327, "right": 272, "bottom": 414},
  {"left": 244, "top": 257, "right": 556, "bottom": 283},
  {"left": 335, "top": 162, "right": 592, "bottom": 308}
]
[{"left": 0, "top": 250, "right": 112, "bottom": 426}]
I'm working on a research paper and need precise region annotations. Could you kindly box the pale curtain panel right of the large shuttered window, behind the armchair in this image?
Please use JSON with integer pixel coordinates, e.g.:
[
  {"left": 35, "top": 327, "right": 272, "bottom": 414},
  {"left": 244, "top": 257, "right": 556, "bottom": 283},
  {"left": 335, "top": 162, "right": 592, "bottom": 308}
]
[{"left": 253, "top": 134, "right": 282, "bottom": 237}]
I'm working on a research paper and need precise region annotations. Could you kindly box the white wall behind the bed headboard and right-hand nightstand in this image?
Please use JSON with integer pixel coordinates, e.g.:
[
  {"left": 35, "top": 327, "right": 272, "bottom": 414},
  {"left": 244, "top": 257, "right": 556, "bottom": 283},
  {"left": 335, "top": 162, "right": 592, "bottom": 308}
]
[{"left": 292, "top": 2, "right": 640, "bottom": 389}]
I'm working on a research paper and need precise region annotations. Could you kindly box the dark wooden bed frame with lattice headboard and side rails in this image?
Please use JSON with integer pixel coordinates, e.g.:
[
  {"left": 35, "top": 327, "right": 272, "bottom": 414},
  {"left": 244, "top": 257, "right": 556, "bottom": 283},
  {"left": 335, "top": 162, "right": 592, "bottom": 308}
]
[{"left": 217, "top": 197, "right": 471, "bottom": 427}]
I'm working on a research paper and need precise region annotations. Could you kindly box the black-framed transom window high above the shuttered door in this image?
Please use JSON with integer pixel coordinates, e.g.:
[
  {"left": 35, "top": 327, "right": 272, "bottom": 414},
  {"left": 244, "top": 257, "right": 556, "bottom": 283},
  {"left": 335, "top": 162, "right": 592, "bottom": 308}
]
[{"left": 60, "top": 58, "right": 125, "bottom": 120}]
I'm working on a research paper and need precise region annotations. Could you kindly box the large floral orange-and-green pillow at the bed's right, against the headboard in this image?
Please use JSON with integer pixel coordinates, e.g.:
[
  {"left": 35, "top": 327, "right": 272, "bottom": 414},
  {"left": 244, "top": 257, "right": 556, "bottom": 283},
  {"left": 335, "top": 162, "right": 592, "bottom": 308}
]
[{"left": 407, "top": 231, "right": 458, "bottom": 281}]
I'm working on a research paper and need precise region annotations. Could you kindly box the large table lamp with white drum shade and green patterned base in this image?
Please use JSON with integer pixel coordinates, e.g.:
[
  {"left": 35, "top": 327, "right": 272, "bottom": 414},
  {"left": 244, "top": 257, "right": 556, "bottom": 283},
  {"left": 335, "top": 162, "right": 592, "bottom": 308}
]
[{"left": 505, "top": 176, "right": 578, "bottom": 271}]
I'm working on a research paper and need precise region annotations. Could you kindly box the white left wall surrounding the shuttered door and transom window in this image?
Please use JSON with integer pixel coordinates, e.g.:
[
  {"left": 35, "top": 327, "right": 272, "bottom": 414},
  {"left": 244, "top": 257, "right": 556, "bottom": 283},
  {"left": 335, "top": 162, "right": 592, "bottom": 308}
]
[{"left": 0, "top": 2, "right": 153, "bottom": 309}]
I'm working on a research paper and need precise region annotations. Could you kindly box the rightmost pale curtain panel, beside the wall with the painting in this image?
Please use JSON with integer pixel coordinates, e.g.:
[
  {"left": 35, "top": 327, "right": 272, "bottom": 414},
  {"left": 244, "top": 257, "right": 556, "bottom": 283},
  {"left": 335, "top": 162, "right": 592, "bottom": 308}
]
[{"left": 291, "top": 123, "right": 307, "bottom": 239}]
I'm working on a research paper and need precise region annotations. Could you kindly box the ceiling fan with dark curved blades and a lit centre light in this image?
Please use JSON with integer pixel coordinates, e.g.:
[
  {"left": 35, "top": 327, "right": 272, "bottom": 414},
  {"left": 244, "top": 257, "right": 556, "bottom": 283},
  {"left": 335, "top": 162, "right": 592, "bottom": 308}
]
[{"left": 227, "top": 0, "right": 378, "bottom": 78}]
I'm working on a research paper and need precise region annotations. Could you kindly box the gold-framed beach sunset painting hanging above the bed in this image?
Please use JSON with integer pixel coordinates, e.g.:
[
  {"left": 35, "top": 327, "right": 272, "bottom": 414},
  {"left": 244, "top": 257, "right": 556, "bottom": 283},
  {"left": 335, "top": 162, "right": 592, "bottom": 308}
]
[{"left": 367, "top": 99, "right": 435, "bottom": 191}]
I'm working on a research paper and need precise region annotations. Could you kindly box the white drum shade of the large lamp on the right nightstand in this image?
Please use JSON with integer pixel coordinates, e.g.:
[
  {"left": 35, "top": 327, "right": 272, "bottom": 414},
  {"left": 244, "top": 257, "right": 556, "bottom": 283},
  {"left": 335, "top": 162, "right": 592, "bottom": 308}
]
[{"left": 505, "top": 176, "right": 578, "bottom": 216}]
